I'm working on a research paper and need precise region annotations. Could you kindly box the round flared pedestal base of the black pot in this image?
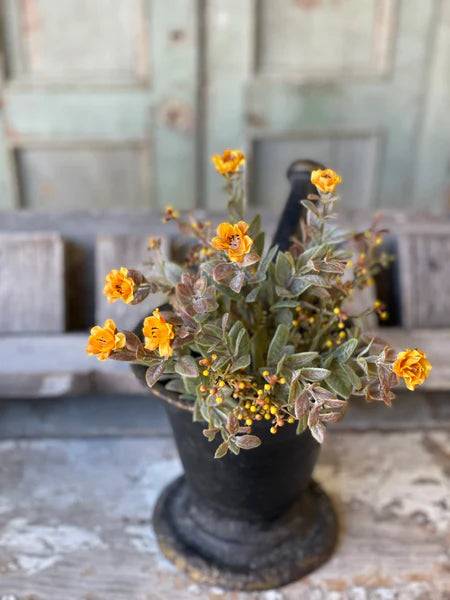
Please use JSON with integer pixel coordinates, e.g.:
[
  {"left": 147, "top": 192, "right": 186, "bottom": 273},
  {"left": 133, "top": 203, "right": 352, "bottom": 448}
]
[{"left": 153, "top": 476, "right": 337, "bottom": 591}]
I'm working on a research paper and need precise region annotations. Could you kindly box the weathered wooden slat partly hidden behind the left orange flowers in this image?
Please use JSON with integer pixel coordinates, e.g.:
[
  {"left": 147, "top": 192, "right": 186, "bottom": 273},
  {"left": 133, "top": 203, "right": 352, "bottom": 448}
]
[{"left": 95, "top": 235, "right": 168, "bottom": 330}]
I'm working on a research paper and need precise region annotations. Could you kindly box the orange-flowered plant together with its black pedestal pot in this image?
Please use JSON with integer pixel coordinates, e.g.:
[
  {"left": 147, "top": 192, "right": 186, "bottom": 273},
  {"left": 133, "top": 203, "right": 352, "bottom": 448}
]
[{"left": 86, "top": 150, "right": 431, "bottom": 590}]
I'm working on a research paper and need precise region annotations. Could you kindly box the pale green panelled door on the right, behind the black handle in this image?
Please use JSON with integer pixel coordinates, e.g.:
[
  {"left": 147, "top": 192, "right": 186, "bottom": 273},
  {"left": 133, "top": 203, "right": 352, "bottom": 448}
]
[{"left": 205, "top": 0, "right": 450, "bottom": 210}]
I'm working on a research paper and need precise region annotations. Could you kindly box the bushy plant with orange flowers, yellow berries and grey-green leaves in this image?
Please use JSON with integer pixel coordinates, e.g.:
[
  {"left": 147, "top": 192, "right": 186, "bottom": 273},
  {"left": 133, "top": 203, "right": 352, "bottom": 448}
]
[{"left": 86, "top": 150, "right": 431, "bottom": 457}]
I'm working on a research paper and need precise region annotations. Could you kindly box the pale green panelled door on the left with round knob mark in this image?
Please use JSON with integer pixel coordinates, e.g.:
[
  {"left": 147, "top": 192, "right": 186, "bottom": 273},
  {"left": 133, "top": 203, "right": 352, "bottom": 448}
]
[{"left": 0, "top": 0, "right": 199, "bottom": 211}]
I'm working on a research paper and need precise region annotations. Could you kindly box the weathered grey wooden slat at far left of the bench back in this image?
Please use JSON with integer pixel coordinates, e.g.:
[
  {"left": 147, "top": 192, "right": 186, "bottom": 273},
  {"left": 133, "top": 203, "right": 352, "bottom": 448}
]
[{"left": 0, "top": 233, "right": 65, "bottom": 333}]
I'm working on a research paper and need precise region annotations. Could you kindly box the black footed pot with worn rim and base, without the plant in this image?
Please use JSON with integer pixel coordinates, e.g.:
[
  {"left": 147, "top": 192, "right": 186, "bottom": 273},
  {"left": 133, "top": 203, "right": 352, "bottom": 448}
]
[{"left": 148, "top": 385, "right": 337, "bottom": 590}]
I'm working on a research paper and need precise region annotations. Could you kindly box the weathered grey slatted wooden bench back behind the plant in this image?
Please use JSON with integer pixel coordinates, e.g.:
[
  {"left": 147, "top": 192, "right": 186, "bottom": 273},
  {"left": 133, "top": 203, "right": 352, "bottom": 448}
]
[{"left": 0, "top": 211, "right": 450, "bottom": 398}]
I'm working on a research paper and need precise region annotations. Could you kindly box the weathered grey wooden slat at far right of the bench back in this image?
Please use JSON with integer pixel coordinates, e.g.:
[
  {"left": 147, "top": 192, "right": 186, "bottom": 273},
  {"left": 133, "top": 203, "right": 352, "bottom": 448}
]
[{"left": 398, "top": 227, "right": 450, "bottom": 329}]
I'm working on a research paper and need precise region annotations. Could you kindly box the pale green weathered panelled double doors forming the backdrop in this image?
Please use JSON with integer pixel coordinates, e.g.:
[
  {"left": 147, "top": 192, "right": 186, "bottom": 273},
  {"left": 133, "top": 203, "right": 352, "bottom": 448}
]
[{"left": 0, "top": 0, "right": 450, "bottom": 211}]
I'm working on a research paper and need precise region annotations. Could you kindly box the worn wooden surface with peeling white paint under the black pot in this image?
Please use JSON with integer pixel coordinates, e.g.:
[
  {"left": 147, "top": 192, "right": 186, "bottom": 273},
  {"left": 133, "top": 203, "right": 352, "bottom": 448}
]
[{"left": 0, "top": 430, "right": 450, "bottom": 600}]
